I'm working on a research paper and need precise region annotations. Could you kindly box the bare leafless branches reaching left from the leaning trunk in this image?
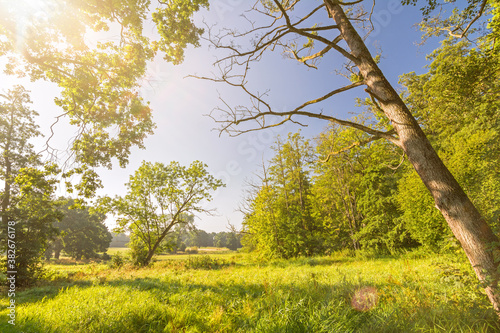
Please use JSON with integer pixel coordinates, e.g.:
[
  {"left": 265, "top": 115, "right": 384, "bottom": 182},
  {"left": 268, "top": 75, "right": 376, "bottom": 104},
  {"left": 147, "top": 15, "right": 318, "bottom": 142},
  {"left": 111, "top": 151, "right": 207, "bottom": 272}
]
[{"left": 196, "top": 0, "right": 399, "bottom": 145}]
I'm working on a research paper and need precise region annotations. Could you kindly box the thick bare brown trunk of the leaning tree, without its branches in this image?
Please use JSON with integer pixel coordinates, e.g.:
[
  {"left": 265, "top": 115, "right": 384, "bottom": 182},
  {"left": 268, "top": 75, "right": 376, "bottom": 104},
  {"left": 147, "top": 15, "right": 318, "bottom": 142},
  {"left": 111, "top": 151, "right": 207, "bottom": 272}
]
[{"left": 325, "top": 0, "right": 500, "bottom": 313}]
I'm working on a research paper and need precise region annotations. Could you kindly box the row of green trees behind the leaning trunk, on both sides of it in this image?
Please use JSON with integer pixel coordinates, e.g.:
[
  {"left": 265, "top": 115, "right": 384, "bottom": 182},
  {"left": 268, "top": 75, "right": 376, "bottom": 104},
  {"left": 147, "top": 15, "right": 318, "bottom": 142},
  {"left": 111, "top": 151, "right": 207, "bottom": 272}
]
[{"left": 243, "top": 37, "right": 500, "bottom": 258}]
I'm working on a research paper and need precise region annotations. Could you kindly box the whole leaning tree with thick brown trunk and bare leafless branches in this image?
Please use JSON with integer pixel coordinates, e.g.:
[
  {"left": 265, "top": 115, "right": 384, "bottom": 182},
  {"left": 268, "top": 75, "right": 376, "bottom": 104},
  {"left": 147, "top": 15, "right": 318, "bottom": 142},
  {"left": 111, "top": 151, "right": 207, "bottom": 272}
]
[{"left": 197, "top": 0, "right": 500, "bottom": 313}]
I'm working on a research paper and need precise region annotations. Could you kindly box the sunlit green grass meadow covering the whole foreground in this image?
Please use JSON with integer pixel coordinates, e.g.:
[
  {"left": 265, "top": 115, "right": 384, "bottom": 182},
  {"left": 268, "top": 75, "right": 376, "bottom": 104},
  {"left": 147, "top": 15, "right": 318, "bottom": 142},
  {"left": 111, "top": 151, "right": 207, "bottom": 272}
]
[{"left": 0, "top": 253, "right": 500, "bottom": 333}]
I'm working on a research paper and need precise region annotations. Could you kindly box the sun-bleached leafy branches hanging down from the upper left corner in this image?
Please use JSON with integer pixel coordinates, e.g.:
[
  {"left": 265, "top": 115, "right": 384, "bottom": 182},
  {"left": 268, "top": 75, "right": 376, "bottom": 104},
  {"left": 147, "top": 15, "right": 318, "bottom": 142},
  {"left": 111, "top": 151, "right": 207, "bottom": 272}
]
[{"left": 0, "top": 0, "right": 208, "bottom": 197}]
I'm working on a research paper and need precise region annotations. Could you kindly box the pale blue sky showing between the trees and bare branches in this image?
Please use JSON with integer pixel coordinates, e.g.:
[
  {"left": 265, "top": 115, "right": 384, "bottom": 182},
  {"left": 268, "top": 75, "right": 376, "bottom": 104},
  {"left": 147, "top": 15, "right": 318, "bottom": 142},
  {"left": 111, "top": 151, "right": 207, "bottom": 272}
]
[{"left": 0, "top": 0, "right": 437, "bottom": 231}]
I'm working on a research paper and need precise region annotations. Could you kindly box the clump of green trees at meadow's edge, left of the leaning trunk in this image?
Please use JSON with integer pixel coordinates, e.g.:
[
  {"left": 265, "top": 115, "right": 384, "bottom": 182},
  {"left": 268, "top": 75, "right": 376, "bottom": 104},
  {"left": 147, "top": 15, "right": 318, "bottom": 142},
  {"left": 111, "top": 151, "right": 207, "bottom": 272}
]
[{"left": 242, "top": 124, "right": 417, "bottom": 258}]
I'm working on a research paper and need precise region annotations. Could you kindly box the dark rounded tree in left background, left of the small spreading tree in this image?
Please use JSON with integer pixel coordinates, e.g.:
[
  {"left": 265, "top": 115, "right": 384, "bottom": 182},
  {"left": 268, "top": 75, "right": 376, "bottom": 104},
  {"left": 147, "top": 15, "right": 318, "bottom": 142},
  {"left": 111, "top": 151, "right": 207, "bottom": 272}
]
[{"left": 48, "top": 199, "right": 112, "bottom": 260}]
